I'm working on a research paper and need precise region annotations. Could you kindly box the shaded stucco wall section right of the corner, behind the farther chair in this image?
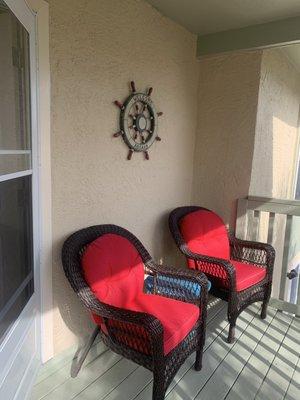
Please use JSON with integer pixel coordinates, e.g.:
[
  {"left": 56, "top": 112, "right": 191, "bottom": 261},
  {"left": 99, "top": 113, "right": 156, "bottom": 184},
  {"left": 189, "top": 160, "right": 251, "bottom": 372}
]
[{"left": 193, "top": 51, "right": 262, "bottom": 227}]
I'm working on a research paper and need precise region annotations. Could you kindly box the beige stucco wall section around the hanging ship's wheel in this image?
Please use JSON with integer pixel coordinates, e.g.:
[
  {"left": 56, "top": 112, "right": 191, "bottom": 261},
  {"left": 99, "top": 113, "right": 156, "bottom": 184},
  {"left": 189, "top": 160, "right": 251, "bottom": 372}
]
[{"left": 49, "top": 0, "right": 198, "bottom": 353}]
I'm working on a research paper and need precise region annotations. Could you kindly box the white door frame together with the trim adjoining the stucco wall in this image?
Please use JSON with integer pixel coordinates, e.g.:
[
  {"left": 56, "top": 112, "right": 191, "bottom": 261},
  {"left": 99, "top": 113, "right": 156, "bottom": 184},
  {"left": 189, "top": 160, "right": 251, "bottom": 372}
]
[{"left": 0, "top": 0, "right": 53, "bottom": 400}]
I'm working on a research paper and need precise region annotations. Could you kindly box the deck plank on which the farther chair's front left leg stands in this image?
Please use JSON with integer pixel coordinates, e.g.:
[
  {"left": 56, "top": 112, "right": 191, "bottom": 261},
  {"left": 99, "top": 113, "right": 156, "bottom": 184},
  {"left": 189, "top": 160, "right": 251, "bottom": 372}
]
[{"left": 162, "top": 306, "right": 258, "bottom": 400}]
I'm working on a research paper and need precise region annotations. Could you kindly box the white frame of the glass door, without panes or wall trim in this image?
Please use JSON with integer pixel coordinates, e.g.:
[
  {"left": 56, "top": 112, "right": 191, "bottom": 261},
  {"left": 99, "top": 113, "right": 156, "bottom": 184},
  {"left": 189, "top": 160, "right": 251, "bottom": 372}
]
[{"left": 0, "top": 0, "right": 44, "bottom": 400}]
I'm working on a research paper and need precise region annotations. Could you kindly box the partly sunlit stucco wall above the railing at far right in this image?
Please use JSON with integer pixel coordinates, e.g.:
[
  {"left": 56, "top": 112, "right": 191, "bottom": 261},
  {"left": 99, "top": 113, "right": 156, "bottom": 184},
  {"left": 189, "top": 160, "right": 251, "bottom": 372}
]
[{"left": 250, "top": 49, "right": 300, "bottom": 198}]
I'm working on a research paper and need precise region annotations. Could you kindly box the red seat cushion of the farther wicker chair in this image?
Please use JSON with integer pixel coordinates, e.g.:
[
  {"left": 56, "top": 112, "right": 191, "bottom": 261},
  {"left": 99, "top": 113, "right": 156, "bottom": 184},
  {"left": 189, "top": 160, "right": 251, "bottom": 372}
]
[{"left": 230, "top": 260, "right": 266, "bottom": 292}]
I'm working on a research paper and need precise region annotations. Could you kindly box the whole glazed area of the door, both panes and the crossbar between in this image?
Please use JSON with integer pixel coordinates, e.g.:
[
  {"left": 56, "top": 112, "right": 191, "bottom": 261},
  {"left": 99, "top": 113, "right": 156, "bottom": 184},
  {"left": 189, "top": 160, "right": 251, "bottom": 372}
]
[{"left": 0, "top": 1, "right": 33, "bottom": 340}]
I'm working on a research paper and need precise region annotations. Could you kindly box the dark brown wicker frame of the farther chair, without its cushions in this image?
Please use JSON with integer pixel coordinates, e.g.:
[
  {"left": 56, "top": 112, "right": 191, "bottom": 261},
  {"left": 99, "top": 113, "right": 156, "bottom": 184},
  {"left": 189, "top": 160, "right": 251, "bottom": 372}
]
[{"left": 169, "top": 206, "right": 275, "bottom": 343}]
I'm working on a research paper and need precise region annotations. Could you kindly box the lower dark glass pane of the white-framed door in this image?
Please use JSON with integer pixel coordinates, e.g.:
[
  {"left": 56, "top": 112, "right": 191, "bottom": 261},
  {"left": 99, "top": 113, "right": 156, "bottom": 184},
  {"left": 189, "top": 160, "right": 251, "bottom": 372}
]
[{"left": 0, "top": 176, "right": 33, "bottom": 337}]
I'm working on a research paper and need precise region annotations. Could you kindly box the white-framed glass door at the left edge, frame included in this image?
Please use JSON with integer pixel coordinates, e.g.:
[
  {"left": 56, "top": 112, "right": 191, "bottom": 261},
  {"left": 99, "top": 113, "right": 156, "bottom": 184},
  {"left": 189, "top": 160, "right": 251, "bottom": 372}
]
[{"left": 0, "top": 0, "right": 40, "bottom": 400}]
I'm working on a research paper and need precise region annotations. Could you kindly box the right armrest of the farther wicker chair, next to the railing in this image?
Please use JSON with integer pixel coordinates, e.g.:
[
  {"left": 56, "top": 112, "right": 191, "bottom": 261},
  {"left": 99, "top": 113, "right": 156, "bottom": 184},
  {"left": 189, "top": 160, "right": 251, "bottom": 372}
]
[{"left": 230, "top": 236, "right": 275, "bottom": 273}]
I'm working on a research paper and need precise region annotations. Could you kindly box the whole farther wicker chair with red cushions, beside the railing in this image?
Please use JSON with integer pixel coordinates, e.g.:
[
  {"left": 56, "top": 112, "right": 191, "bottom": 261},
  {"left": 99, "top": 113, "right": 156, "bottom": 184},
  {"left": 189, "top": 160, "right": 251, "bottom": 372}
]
[{"left": 169, "top": 206, "right": 275, "bottom": 343}]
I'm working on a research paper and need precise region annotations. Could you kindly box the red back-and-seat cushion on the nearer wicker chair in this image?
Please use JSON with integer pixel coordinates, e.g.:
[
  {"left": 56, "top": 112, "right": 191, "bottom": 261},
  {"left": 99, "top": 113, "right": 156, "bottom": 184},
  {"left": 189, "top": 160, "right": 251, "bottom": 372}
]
[{"left": 82, "top": 234, "right": 199, "bottom": 354}]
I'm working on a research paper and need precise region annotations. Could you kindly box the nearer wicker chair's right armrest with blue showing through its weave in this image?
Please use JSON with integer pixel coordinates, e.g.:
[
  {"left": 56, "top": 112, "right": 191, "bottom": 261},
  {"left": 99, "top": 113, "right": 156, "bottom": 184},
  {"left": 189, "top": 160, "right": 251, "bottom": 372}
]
[{"left": 146, "top": 262, "right": 208, "bottom": 307}]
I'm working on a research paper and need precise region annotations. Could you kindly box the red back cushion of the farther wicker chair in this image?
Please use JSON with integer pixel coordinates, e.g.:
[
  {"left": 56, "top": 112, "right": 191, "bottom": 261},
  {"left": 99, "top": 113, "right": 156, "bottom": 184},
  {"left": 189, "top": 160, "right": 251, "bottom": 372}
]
[{"left": 180, "top": 210, "right": 230, "bottom": 260}]
